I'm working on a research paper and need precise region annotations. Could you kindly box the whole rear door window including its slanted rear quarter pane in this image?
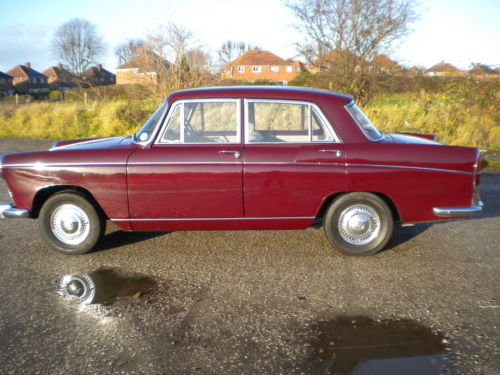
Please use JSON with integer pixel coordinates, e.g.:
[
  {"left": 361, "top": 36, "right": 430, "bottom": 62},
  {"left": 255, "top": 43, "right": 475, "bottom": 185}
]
[{"left": 245, "top": 100, "right": 335, "bottom": 143}]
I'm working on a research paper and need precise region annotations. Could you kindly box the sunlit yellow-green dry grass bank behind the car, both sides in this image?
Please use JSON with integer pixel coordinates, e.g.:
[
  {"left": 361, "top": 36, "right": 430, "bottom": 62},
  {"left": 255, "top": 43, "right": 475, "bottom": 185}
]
[{"left": 0, "top": 86, "right": 500, "bottom": 150}]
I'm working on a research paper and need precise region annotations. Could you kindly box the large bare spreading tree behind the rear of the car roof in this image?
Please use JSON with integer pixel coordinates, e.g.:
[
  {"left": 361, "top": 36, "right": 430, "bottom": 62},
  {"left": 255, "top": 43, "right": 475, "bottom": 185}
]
[{"left": 287, "top": 0, "right": 416, "bottom": 97}]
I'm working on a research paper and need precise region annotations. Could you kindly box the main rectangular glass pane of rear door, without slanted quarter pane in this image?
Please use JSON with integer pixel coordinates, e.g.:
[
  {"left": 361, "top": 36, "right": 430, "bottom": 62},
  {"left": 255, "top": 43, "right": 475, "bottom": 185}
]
[{"left": 247, "top": 102, "right": 309, "bottom": 143}]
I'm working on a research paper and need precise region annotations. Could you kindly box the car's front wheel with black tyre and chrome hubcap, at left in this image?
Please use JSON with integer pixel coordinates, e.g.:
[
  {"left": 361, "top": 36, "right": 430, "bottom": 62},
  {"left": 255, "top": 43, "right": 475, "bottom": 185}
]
[{"left": 38, "top": 192, "right": 105, "bottom": 255}]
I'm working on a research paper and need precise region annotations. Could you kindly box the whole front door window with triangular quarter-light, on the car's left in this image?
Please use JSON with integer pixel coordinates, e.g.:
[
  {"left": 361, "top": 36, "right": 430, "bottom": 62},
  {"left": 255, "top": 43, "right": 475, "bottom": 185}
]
[{"left": 160, "top": 100, "right": 240, "bottom": 143}]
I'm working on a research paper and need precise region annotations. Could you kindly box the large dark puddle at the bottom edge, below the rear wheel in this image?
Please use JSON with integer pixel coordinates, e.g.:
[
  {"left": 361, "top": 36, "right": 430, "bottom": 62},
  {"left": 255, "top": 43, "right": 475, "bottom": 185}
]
[{"left": 311, "top": 317, "right": 447, "bottom": 375}]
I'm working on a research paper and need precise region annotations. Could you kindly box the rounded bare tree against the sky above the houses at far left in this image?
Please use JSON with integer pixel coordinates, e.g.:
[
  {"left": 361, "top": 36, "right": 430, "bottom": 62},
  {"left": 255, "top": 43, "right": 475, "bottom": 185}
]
[{"left": 52, "top": 18, "right": 105, "bottom": 75}]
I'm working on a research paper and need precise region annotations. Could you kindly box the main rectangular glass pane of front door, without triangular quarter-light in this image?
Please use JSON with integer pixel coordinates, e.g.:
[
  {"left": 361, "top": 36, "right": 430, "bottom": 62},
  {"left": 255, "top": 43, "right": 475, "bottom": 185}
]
[{"left": 184, "top": 102, "right": 239, "bottom": 143}]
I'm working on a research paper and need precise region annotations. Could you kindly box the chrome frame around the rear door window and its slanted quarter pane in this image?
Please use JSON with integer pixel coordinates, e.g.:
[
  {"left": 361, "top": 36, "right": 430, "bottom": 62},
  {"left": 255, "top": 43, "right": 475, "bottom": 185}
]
[{"left": 243, "top": 98, "right": 343, "bottom": 145}]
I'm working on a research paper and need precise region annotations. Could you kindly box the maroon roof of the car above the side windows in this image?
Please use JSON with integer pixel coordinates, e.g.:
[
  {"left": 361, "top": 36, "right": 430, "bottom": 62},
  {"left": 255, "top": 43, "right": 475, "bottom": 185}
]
[{"left": 167, "top": 86, "right": 353, "bottom": 105}]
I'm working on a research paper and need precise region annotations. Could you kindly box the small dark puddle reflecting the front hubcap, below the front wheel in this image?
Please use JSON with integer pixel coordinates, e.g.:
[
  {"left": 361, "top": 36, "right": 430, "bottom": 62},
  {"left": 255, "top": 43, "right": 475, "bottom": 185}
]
[{"left": 56, "top": 268, "right": 156, "bottom": 304}]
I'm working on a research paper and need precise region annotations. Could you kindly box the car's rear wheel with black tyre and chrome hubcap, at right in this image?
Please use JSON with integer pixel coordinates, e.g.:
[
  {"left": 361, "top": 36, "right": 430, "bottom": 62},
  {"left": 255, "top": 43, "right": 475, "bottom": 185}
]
[{"left": 323, "top": 192, "right": 394, "bottom": 256}]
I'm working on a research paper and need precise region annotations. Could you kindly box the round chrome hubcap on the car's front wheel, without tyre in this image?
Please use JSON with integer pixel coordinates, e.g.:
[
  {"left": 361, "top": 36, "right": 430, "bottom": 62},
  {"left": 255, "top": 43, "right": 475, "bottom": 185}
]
[{"left": 50, "top": 204, "right": 90, "bottom": 245}]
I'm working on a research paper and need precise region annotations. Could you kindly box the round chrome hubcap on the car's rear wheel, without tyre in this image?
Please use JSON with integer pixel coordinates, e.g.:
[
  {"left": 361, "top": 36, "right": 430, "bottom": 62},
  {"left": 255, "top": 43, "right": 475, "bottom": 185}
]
[{"left": 338, "top": 204, "right": 380, "bottom": 245}]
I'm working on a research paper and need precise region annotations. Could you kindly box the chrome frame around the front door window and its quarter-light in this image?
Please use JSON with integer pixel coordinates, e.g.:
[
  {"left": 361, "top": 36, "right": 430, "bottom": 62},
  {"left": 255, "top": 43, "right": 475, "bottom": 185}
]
[{"left": 154, "top": 98, "right": 241, "bottom": 146}]
